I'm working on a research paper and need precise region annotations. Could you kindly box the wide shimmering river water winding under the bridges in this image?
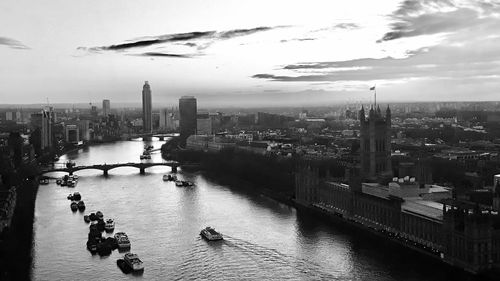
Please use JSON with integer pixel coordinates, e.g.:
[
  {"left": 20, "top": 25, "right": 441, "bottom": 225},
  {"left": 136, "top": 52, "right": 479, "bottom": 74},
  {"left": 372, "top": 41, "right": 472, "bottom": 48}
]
[{"left": 32, "top": 140, "right": 478, "bottom": 280}]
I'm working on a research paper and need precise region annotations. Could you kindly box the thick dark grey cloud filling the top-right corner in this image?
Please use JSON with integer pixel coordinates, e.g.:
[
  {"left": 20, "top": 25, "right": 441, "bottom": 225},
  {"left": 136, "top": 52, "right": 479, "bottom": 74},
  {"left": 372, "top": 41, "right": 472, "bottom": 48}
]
[{"left": 377, "top": 0, "right": 500, "bottom": 43}]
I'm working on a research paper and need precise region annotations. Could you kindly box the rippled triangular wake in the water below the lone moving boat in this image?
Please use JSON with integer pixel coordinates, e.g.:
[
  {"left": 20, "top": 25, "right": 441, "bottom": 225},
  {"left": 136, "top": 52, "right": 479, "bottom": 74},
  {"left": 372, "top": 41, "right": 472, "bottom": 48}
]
[{"left": 174, "top": 234, "right": 341, "bottom": 280}]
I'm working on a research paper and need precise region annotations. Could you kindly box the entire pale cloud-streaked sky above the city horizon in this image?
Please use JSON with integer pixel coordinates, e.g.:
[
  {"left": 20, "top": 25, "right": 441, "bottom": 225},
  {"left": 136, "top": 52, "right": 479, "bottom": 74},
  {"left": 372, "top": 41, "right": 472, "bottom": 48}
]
[{"left": 0, "top": 0, "right": 500, "bottom": 107}]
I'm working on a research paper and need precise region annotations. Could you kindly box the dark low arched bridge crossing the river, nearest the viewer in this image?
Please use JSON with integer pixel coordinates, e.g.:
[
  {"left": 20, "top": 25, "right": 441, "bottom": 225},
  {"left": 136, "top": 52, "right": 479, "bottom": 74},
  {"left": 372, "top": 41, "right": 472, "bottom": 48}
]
[{"left": 41, "top": 161, "right": 179, "bottom": 176}]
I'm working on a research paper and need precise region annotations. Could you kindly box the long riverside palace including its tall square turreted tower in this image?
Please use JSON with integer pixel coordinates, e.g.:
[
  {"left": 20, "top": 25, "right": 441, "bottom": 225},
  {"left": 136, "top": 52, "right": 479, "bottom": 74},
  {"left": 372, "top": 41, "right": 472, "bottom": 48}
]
[{"left": 295, "top": 108, "right": 500, "bottom": 273}]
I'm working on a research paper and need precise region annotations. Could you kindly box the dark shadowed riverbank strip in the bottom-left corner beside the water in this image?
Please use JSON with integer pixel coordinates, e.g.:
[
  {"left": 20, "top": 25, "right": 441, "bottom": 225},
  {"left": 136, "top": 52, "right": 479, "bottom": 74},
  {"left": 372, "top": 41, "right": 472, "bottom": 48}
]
[{"left": 0, "top": 177, "right": 38, "bottom": 281}]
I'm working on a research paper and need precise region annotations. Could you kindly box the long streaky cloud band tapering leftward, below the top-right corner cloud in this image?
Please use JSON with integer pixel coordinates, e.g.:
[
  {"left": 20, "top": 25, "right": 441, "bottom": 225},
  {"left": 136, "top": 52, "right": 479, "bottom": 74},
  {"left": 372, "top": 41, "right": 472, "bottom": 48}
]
[{"left": 252, "top": 33, "right": 500, "bottom": 83}]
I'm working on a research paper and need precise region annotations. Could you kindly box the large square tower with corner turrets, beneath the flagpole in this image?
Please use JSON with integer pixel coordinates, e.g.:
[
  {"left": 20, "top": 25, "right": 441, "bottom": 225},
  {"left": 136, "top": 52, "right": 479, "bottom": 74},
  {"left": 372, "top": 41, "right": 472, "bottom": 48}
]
[{"left": 359, "top": 107, "right": 392, "bottom": 180}]
